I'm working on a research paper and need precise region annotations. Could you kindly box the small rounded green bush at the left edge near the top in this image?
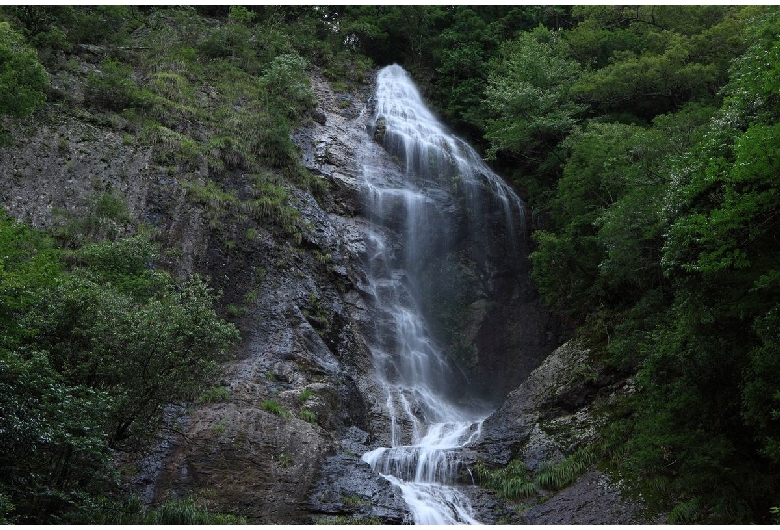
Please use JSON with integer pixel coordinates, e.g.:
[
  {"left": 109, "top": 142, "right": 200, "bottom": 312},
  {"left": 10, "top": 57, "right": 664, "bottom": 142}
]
[{"left": 0, "top": 22, "right": 49, "bottom": 117}]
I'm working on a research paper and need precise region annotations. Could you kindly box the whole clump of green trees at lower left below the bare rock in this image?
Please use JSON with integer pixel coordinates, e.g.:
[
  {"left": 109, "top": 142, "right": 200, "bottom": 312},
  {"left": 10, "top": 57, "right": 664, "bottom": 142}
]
[{"left": 0, "top": 210, "right": 238, "bottom": 523}]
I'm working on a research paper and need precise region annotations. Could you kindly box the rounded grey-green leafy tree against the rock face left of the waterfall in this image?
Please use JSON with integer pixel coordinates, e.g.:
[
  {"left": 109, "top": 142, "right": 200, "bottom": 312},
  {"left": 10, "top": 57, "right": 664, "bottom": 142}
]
[{"left": 25, "top": 236, "right": 238, "bottom": 446}]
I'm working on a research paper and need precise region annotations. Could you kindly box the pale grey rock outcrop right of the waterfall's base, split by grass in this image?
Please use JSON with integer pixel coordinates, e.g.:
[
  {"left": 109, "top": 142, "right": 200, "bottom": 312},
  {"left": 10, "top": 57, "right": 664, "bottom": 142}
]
[{"left": 474, "top": 341, "right": 645, "bottom": 524}]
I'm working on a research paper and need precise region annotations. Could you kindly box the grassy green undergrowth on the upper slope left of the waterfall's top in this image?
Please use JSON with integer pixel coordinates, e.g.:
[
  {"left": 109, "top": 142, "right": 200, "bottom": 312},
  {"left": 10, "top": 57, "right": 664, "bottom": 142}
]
[{"left": 39, "top": 7, "right": 330, "bottom": 242}]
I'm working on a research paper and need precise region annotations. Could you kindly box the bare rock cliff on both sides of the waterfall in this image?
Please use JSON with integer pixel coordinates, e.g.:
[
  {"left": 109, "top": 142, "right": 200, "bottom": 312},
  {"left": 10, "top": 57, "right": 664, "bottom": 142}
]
[{"left": 0, "top": 59, "right": 640, "bottom": 523}]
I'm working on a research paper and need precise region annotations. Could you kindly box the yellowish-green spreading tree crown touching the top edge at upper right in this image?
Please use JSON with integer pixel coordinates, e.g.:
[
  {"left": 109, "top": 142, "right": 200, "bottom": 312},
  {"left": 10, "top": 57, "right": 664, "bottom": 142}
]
[{"left": 566, "top": 6, "right": 756, "bottom": 120}]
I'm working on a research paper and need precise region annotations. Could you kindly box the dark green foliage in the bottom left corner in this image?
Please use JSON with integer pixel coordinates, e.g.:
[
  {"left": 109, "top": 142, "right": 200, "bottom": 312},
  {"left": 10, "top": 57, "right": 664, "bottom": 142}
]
[{"left": 0, "top": 347, "right": 116, "bottom": 524}]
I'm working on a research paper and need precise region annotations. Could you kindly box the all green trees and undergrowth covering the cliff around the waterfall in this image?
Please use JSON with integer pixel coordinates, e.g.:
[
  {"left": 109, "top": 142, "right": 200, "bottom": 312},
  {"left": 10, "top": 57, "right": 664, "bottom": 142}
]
[{"left": 0, "top": 6, "right": 780, "bottom": 523}]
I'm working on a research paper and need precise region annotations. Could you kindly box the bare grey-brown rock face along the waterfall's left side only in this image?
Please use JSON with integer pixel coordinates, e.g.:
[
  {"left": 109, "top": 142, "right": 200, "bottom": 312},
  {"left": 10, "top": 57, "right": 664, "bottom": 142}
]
[{"left": 0, "top": 63, "right": 406, "bottom": 523}]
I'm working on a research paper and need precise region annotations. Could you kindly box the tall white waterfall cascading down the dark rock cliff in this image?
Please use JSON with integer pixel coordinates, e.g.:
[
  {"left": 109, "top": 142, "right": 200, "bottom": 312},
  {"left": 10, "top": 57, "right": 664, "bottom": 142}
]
[{"left": 360, "top": 65, "right": 524, "bottom": 524}]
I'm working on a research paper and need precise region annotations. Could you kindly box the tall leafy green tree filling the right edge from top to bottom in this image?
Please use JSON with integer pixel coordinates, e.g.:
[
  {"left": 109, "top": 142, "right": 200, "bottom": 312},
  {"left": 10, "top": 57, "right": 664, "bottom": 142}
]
[{"left": 610, "top": 12, "right": 780, "bottom": 522}]
